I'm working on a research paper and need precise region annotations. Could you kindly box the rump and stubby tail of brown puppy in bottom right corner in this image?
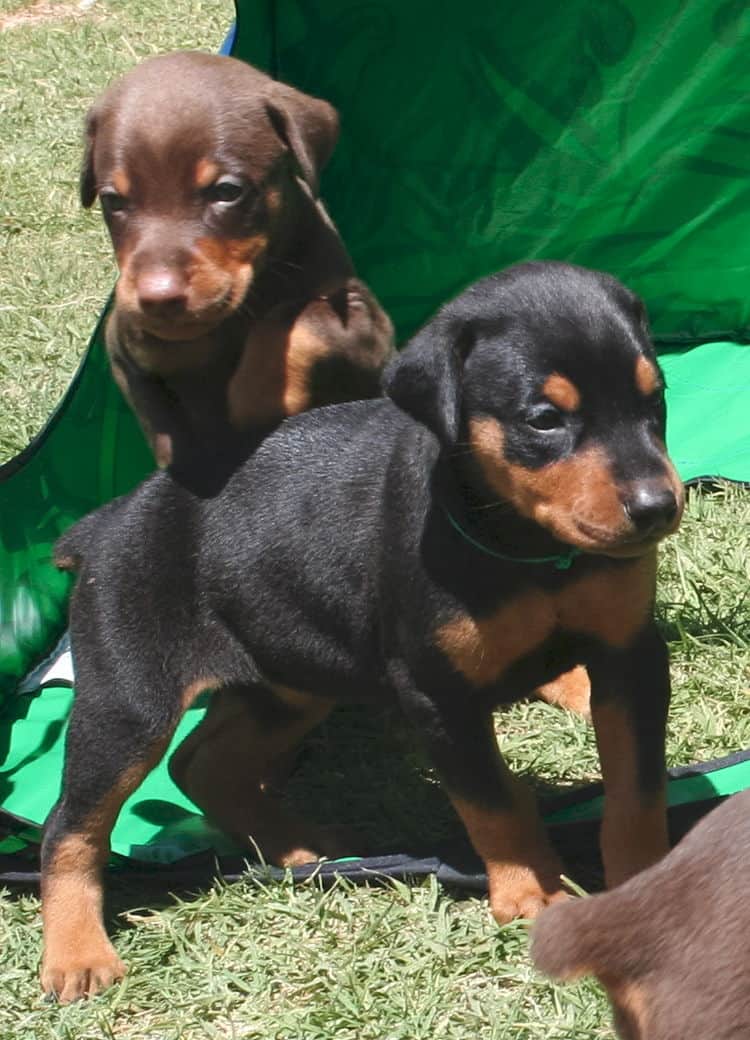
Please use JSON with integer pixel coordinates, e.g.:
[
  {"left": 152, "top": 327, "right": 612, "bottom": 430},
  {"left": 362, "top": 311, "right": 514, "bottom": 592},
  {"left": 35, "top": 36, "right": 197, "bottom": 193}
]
[{"left": 532, "top": 791, "right": 750, "bottom": 1040}]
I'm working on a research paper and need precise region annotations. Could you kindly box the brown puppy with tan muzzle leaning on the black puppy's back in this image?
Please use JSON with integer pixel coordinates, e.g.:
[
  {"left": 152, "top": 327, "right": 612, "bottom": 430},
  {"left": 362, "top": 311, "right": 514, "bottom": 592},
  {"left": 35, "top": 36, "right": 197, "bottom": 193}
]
[{"left": 81, "top": 53, "right": 392, "bottom": 491}]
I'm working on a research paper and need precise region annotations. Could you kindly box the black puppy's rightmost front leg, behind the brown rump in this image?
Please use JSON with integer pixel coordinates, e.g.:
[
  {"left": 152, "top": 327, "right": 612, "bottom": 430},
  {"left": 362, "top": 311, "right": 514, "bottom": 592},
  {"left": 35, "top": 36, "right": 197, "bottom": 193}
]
[{"left": 589, "top": 621, "right": 670, "bottom": 887}]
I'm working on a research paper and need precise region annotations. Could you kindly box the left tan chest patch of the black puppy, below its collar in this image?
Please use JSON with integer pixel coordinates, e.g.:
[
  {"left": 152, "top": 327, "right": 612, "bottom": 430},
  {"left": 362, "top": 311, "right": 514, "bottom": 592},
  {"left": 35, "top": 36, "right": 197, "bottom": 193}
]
[{"left": 435, "top": 592, "right": 555, "bottom": 686}]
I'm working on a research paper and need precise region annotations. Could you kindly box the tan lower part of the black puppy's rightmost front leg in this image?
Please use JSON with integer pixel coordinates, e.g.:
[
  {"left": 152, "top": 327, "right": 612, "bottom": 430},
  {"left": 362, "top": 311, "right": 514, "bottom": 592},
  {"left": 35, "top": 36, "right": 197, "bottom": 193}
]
[{"left": 592, "top": 701, "right": 669, "bottom": 888}]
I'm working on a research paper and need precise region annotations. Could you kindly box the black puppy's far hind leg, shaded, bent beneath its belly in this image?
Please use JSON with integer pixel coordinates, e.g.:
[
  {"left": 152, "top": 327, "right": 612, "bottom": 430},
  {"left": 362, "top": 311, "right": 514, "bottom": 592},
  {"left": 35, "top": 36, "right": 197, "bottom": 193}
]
[{"left": 170, "top": 684, "right": 352, "bottom": 866}]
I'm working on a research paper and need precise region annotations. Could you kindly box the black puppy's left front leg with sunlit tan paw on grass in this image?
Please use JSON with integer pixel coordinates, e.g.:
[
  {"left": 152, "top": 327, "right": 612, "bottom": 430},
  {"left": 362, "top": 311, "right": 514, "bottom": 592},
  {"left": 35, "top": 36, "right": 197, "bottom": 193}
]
[{"left": 404, "top": 692, "right": 564, "bottom": 924}]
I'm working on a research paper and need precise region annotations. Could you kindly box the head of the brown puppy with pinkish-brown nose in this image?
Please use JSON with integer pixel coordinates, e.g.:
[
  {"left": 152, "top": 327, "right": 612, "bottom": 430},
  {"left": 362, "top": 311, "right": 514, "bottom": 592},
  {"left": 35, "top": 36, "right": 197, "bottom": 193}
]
[{"left": 81, "top": 53, "right": 338, "bottom": 340}]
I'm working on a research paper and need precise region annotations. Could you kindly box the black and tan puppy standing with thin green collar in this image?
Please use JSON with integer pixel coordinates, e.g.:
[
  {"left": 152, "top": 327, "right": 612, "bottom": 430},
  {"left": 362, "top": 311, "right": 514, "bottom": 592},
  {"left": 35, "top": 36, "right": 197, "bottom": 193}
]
[{"left": 42, "top": 263, "right": 682, "bottom": 999}]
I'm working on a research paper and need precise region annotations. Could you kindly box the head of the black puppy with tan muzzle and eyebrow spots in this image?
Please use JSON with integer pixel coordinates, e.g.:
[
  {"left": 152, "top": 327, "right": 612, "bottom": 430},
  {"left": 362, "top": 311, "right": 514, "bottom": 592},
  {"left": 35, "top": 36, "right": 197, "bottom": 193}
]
[{"left": 386, "top": 263, "right": 683, "bottom": 556}]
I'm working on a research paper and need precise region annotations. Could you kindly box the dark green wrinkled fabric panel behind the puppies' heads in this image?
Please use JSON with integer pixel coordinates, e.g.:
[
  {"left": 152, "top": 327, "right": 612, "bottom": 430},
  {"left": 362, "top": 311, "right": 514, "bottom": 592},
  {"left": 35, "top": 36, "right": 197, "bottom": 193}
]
[{"left": 236, "top": 0, "right": 750, "bottom": 342}]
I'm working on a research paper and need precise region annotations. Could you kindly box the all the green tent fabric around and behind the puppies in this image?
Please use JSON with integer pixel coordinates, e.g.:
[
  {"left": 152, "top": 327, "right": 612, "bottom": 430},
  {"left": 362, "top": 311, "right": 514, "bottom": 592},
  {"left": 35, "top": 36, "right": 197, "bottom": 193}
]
[{"left": 0, "top": 0, "right": 750, "bottom": 859}]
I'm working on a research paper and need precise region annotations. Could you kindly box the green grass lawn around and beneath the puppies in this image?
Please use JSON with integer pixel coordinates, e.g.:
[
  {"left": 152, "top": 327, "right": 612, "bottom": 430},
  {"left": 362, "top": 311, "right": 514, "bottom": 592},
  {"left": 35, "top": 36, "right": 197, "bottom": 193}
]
[{"left": 0, "top": 0, "right": 750, "bottom": 1040}]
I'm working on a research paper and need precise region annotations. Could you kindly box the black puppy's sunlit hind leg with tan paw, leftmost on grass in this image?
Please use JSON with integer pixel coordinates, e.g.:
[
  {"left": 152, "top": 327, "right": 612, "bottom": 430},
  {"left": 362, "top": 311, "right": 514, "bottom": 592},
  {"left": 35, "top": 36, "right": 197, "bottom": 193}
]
[{"left": 41, "top": 661, "right": 195, "bottom": 1004}]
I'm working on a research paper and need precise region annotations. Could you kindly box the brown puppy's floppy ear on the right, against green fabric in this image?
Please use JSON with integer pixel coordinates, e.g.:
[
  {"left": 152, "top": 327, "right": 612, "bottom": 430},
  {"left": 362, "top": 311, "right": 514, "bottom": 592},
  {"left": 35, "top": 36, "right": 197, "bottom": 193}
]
[{"left": 265, "top": 83, "right": 338, "bottom": 196}]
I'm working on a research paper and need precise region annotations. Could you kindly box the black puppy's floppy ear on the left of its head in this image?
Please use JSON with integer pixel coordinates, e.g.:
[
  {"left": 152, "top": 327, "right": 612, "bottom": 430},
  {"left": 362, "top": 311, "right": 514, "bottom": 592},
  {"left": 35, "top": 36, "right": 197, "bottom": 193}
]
[{"left": 383, "top": 314, "right": 473, "bottom": 445}]
